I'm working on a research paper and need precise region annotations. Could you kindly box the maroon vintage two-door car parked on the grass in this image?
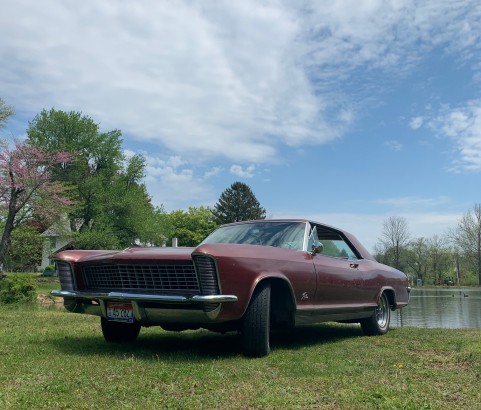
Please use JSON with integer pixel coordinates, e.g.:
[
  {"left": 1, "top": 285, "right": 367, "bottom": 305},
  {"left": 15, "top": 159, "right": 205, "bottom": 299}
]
[{"left": 51, "top": 219, "right": 410, "bottom": 357}]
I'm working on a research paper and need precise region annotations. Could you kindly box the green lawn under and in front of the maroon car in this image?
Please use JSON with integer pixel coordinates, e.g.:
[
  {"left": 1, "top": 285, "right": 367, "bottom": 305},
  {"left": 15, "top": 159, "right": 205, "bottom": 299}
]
[{"left": 0, "top": 283, "right": 481, "bottom": 409}]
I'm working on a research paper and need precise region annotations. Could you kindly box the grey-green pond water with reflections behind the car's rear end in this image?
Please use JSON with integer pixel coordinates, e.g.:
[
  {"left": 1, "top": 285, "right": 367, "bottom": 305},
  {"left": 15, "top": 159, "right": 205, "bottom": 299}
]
[{"left": 391, "top": 288, "right": 481, "bottom": 329}]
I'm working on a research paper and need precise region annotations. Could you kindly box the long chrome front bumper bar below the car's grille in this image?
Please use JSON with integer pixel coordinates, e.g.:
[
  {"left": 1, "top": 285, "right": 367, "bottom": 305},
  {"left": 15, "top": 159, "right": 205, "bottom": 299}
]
[{"left": 50, "top": 290, "right": 237, "bottom": 303}]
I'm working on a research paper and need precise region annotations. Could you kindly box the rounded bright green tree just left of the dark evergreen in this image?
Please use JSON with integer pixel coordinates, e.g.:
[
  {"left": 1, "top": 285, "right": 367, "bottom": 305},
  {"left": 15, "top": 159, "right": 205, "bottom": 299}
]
[{"left": 167, "top": 206, "right": 218, "bottom": 246}]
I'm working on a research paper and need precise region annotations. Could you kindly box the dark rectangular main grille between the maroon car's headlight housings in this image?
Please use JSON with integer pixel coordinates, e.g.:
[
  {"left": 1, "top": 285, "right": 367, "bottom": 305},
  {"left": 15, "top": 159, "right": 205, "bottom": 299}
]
[{"left": 84, "top": 261, "right": 199, "bottom": 293}]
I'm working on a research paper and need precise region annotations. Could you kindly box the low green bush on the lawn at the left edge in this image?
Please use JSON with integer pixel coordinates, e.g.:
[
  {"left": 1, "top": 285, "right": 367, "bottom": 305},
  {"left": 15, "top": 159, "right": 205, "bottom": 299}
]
[{"left": 0, "top": 275, "right": 37, "bottom": 305}]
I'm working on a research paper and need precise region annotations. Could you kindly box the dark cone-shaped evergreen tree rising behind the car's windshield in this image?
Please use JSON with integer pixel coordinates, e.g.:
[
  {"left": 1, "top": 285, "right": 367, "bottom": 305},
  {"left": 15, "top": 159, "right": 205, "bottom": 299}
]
[{"left": 212, "top": 182, "right": 266, "bottom": 224}]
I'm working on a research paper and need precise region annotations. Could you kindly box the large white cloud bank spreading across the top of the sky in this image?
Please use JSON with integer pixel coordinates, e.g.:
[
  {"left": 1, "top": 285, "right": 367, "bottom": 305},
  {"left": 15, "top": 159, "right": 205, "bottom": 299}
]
[{"left": 0, "top": 0, "right": 481, "bottom": 164}]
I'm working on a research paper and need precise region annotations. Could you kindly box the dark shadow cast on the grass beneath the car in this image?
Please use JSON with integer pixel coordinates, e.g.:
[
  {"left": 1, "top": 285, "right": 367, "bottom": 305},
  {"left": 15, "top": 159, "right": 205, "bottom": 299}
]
[{"left": 47, "top": 324, "right": 376, "bottom": 361}]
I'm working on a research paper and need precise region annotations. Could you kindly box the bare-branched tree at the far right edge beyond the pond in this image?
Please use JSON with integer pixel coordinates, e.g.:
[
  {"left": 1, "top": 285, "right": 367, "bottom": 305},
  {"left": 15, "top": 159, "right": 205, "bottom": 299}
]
[{"left": 451, "top": 204, "right": 481, "bottom": 286}]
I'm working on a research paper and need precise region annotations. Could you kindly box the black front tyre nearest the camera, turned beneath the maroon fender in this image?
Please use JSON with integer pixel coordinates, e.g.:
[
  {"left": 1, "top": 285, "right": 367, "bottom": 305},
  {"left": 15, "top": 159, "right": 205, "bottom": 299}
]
[{"left": 241, "top": 283, "right": 271, "bottom": 357}]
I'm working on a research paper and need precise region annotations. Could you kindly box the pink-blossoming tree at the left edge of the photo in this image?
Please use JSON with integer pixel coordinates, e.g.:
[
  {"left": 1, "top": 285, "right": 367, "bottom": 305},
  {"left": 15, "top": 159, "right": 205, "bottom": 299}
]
[{"left": 0, "top": 141, "right": 71, "bottom": 263}]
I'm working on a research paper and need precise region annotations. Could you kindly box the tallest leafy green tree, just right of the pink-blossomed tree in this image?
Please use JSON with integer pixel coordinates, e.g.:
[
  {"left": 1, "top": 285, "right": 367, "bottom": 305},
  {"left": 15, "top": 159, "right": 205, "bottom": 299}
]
[{"left": 27, "top": 108, "right": 124, "bottom": 231}]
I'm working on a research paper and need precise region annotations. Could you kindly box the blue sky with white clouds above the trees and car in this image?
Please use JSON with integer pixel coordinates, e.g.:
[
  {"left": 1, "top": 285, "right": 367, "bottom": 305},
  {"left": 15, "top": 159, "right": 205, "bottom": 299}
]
[{"left": 0, "top": 0, "right": 481, "bottom": 251}]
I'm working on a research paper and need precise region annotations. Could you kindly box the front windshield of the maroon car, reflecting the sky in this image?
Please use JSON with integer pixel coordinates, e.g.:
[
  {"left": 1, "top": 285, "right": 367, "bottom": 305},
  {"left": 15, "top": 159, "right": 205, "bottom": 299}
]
[{"left": 202, "top": 222, "right": 306, "bottom": 250}]
